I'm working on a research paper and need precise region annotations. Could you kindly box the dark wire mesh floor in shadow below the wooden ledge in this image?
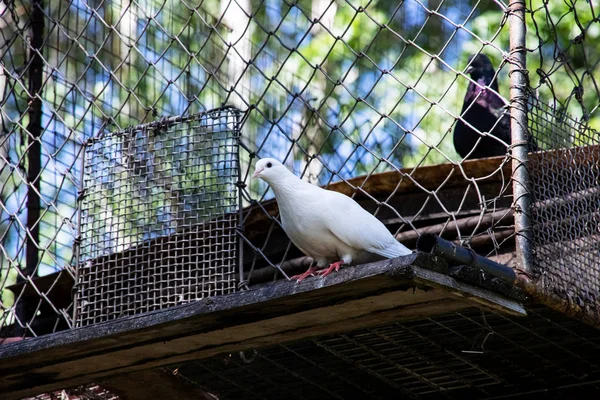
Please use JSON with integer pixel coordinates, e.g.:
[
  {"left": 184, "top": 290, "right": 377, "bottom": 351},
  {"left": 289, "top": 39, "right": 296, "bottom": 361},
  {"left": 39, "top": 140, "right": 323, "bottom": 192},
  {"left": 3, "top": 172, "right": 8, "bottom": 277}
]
[{"left": 173, "top": 307, "right": 600, "bottom": 400}]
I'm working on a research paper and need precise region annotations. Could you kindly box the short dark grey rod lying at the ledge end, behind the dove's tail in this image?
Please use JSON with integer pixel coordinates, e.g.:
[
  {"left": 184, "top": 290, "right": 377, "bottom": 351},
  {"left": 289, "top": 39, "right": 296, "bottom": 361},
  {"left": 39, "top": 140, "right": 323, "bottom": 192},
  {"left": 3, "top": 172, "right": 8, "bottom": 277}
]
[{"left": 417, "top": 233, "right": 516, "bottom": 283}]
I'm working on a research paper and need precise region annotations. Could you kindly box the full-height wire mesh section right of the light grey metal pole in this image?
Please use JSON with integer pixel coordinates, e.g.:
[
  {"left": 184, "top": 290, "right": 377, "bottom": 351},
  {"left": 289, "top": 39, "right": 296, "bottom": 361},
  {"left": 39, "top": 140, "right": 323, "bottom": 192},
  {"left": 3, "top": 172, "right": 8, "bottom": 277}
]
[{"left": 526, "top": 1, "right": 600, "bottom": 322}]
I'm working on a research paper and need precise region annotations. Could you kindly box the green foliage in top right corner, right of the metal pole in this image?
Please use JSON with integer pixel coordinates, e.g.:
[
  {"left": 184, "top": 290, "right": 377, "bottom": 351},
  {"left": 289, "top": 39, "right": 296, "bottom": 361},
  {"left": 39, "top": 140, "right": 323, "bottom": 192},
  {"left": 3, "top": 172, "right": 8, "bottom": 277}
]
[{"left": 473, "top": 0, "right": 600, "bottom": 130}]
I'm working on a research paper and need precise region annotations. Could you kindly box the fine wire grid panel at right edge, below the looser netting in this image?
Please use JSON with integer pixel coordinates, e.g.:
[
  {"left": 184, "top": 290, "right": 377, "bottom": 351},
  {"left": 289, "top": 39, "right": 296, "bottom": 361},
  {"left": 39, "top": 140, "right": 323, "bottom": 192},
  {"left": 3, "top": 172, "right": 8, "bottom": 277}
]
[{"left": 529, "top": 100, "right": 600, "bottom": 319}]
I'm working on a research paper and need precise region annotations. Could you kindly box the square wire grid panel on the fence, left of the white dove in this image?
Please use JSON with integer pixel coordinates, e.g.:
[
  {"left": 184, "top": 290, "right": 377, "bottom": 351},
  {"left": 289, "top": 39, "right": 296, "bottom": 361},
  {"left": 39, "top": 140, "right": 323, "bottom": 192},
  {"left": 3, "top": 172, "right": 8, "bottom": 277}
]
[{"left": 75, "top": 108, "right": 240, "bottom": 326}]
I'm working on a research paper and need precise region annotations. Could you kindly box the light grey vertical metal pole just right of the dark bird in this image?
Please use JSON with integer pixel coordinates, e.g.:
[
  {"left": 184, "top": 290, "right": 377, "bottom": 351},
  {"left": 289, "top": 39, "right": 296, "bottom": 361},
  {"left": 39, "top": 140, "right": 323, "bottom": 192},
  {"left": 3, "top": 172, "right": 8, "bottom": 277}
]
[{"left": 508, "top": 0, "right": 533, "bottom": 276}]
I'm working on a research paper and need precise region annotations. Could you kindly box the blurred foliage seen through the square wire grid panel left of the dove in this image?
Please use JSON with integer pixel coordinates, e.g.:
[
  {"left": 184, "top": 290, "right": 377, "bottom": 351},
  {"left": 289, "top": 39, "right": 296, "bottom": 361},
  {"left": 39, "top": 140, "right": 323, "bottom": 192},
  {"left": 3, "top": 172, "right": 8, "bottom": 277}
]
[{"left": 81, "top": 116, "right": 237, "bottom": 260}]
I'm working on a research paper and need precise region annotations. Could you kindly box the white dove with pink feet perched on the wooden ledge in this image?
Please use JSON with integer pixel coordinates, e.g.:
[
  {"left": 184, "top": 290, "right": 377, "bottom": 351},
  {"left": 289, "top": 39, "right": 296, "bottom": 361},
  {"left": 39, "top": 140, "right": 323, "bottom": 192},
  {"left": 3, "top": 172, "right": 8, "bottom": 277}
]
[{"left": 252, "top": 158, "right": 412, "bottom": 282}]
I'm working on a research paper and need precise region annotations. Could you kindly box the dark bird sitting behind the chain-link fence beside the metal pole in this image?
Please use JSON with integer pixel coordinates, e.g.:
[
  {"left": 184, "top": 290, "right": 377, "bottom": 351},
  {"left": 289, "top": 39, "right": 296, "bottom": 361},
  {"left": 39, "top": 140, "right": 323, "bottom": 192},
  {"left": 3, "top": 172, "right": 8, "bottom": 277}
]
[{"left": 454, "top": 54, "right": 538, "bottom": 159}]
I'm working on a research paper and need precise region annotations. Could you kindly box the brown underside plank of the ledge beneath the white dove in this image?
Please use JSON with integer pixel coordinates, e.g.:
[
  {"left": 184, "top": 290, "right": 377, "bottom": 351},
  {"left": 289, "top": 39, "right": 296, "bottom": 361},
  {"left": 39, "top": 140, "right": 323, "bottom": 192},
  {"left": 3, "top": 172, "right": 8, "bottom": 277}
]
[{"left": 0, "top": 296, "right": 472, "bottom": 400}]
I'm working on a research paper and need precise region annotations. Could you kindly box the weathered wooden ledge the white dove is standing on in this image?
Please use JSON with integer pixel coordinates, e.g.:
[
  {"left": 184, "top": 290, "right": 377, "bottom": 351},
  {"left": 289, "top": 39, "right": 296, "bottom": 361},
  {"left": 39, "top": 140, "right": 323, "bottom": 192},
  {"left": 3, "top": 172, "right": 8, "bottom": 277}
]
[{"left": 0, "top": 253, "right": 525, "bottom": 399}]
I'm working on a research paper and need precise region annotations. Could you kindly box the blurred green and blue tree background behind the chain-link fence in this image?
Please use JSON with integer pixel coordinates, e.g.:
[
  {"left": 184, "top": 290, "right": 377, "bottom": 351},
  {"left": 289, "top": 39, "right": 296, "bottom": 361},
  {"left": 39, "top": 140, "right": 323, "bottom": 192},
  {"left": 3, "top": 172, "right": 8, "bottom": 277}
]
[{"left": 0, "top": 0, "right": 600, "bottom": 307}]
